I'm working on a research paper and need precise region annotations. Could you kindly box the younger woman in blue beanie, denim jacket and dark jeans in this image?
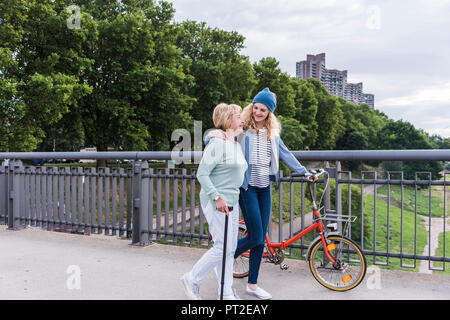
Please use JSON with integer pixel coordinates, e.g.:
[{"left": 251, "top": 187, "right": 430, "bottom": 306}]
[{"left": 235, "top": 88, "right": 309, "bottom": 299}]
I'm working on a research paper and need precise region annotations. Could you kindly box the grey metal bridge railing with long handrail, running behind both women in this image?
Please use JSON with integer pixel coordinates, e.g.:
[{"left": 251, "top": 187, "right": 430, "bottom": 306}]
[{"left": 0, "top": 150, "right": 450, "bottom": 271}]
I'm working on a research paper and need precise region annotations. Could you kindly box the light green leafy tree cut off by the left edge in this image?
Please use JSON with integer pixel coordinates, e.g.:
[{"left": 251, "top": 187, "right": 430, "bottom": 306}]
[{"left": 0, "top": 0, "right": 92, "bottom": 151}]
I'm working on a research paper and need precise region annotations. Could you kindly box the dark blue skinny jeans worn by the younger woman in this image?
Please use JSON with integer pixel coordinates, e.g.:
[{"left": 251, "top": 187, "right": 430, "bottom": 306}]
[{"left": 234, "top": 186, "right": 272, "bottom": 284}]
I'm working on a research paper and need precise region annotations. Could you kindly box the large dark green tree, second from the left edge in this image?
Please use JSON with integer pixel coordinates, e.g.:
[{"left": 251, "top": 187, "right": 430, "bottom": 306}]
[{"left": 72, "top": 0, "right": 193, "bottom": 150}]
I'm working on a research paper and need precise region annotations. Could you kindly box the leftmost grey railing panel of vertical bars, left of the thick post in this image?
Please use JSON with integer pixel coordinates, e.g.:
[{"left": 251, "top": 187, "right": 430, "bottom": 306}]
[{"left": 0, "top": 161, "right": 132, "bottom": 237}]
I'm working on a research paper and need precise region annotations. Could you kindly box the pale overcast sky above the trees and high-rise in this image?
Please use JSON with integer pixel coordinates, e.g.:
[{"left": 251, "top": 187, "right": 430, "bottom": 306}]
[{"left": 169, "top": 0, "right": 450, "bottom": 137}]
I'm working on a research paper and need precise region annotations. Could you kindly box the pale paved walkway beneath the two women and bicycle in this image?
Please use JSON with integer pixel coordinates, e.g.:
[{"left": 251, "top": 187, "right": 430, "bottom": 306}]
[{"left": 0, "top": 226, "right": 450, "bottom": 300}]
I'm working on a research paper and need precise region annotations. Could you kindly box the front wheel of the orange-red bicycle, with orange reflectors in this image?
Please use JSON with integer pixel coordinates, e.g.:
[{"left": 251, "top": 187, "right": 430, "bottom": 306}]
[{"left": 308, "top": 236, "right": 367, "bottom": 291}]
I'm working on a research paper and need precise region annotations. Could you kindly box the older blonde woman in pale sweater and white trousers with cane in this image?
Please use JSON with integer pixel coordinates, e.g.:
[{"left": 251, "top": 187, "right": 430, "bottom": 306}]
[{"left": 181, "top": 104, "right": 248, "bottom": 300}]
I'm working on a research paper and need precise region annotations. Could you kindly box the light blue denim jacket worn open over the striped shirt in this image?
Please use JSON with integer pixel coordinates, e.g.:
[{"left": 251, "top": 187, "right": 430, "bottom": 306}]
[{"left": 205, "top": 130, "right": 308, "bottom": 190}]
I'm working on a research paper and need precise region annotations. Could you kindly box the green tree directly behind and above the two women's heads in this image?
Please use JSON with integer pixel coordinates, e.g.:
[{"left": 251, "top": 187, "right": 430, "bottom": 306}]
[{"left": 176, "top": 21, "right": 255, "bottom": 129}]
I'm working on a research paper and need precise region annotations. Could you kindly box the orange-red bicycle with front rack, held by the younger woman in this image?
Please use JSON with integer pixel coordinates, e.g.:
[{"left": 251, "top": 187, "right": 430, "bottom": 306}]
[{"left": 234, "top": 169, "right": 367, "bottom": 291}]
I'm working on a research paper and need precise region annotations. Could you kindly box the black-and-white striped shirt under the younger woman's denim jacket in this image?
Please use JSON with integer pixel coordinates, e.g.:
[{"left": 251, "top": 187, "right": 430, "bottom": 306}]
[{"left": 249, "top": 129, "right": 272, "bottom": 188}]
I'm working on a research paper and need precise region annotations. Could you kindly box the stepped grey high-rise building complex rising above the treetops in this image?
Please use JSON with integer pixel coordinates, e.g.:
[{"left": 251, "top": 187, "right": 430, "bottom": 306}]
[{"left": 296, "top": 53, "right": 375, "bottom": 109}]
